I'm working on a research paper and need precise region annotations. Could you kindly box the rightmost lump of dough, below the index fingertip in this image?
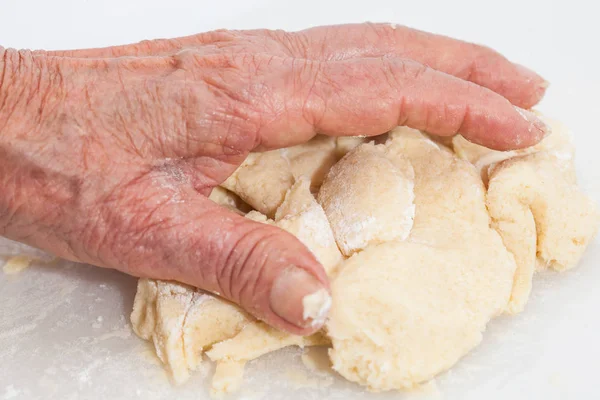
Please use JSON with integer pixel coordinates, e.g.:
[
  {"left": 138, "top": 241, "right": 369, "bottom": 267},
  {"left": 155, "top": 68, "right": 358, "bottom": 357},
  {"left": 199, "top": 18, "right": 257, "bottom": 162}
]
[{"left": 453, "top": 117, "right": 598, "bottom": 313}]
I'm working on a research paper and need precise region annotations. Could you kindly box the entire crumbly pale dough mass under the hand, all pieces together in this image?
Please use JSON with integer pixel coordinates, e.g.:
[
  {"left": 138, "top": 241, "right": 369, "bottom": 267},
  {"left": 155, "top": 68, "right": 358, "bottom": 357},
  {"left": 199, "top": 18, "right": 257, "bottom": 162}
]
[{"left": 131, "top": 120, "right": 600, "bottom": 394}]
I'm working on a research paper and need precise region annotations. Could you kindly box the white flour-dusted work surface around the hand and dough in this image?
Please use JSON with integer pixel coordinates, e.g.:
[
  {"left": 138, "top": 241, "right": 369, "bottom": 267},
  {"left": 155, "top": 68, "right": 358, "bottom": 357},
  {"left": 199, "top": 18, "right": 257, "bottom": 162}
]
[{"left": 0, "top": 0, "right": 600, "bottom": 400}]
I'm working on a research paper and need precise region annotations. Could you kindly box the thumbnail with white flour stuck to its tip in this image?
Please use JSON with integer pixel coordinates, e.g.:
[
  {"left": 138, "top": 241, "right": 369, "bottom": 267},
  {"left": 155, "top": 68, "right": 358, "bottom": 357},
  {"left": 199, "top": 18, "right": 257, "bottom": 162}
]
[{"left": 270, "top": 266, "right": 331, "bottom": 328}]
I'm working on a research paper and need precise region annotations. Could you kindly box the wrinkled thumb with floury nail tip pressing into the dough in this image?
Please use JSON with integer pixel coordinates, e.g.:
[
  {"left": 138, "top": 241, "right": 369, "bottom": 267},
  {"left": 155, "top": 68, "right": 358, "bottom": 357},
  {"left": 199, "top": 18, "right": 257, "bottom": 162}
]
[{"left": 112, "top": 189, "right": 331, "bottom": 335}]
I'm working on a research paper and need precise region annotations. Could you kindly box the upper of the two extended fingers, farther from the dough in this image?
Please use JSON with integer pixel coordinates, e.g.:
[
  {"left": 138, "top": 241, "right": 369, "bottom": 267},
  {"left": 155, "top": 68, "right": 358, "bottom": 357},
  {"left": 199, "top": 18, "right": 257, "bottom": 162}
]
[{"left": 283, "top": 24, "right": 548, "bottom": 108}]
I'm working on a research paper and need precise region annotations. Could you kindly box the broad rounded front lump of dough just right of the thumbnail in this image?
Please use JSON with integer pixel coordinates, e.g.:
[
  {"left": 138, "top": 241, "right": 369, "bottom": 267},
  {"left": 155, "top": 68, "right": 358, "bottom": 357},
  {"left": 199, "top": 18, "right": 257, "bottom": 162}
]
[{"left": 327, "top": 241, "right": 514, "bottom": 391}]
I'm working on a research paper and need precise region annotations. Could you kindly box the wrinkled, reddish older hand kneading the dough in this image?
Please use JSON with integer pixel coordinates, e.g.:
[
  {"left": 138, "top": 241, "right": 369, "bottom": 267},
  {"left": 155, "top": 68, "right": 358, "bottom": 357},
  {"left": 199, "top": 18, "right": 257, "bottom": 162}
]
[{"left": 0, "top": 24, "right": 547, "bottom": 334}]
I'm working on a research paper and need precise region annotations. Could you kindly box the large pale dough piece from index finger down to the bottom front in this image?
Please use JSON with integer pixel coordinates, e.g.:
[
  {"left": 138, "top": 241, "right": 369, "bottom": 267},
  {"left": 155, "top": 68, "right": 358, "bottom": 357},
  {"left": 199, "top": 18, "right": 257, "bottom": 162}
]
[{"left": 327, "top": 128, "right": 516, "bottom": 390}]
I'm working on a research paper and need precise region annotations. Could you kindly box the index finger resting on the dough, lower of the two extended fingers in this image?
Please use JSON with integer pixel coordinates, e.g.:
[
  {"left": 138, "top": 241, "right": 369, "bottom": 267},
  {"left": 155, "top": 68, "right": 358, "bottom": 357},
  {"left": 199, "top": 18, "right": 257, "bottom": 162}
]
[{"left": 253, "top": 58, "right": 548, "bottom": 150}]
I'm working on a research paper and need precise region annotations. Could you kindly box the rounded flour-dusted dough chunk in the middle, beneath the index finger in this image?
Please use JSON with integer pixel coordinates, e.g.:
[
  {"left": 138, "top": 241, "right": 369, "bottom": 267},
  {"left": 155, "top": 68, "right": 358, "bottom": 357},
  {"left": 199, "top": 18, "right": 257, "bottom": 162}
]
[{"left": 319, "top": 143, "right": 415, "bottom": 256}]
